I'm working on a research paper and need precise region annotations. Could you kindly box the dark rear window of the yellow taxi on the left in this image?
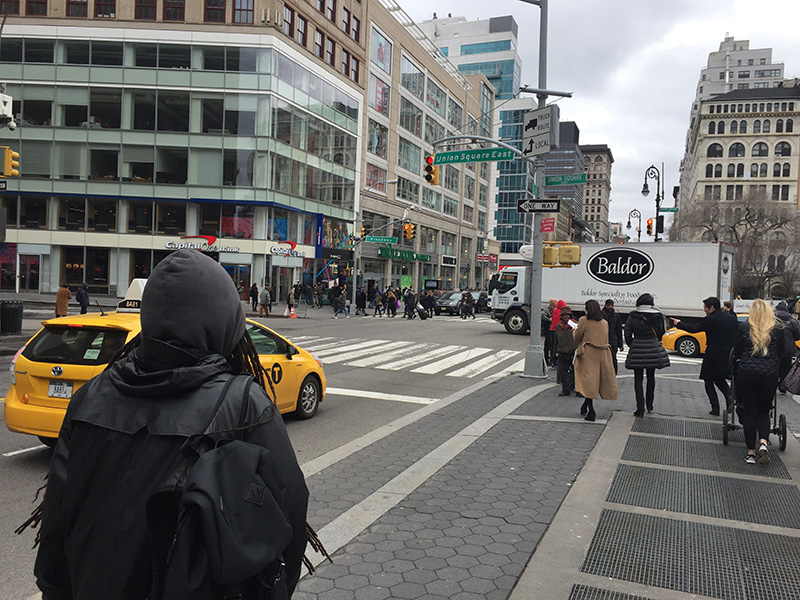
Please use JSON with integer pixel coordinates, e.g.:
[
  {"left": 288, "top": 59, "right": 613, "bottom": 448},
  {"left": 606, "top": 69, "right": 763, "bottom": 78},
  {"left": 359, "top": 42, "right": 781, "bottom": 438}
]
[{"left": 22, "top": 325, "right": 128, "bottom": 366}]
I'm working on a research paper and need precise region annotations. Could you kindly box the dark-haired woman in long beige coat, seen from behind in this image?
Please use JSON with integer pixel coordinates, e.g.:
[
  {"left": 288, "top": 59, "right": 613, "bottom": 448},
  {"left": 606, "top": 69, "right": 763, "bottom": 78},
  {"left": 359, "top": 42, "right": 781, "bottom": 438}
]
[{"left": 575, "top": 300, "right": 619, "bottom": 421}]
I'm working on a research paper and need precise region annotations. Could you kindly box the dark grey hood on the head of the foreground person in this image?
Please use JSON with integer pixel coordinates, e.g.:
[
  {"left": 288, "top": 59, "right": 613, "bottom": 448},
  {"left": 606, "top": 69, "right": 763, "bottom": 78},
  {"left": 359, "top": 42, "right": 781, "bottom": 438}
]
[{"left": 139, "top": 250, "right": 245, "bottom": 368}]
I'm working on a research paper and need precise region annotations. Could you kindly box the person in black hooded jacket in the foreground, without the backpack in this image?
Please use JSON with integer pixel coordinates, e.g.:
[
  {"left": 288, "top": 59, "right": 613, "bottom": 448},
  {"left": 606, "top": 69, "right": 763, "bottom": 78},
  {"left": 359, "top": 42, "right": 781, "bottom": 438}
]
[{"left": 34, "top": 250, "right": 308, "bottom": 600}]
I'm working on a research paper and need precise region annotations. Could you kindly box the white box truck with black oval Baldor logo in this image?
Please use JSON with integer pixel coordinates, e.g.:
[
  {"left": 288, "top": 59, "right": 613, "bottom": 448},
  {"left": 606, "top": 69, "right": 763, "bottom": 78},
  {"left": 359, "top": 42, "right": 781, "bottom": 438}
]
[{"left": 492, "top": 242, "right": 735, "bottom": 334}]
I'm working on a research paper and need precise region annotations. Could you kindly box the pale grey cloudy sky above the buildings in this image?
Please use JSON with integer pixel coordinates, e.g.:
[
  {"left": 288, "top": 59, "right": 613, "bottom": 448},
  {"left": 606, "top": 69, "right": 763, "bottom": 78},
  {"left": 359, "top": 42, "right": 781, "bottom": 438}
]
[{"left": 397, "top": 0, "right": 800, "bottom": 227}]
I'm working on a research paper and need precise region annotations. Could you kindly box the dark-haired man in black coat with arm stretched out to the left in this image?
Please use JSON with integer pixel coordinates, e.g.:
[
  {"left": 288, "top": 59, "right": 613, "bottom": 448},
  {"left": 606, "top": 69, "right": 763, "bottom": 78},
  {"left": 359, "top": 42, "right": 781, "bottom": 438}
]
[{"left": 672, "top": 296, "right": 739, "bottom": 416}]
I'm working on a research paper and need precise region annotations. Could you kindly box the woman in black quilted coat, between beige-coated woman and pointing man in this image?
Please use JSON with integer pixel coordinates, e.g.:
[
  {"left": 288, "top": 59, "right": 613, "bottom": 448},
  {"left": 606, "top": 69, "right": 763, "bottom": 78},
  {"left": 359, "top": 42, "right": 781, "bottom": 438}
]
[{"left": 625, "top": 294, "right": 669, "bottom": 417}]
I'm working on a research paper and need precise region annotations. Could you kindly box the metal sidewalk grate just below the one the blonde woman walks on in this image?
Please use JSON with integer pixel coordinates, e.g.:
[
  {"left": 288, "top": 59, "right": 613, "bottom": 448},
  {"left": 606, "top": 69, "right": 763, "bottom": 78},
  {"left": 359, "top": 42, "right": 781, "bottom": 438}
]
[{"left": 606, "top": 465, "right": 800, "bottom": 529}]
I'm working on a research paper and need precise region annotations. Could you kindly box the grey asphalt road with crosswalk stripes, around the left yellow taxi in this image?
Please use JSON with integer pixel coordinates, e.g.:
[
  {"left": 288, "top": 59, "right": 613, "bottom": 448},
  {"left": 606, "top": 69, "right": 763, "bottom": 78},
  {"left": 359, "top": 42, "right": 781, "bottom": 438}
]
[{"left": 0, "top": 307, "right": 530, "bottom": 599}]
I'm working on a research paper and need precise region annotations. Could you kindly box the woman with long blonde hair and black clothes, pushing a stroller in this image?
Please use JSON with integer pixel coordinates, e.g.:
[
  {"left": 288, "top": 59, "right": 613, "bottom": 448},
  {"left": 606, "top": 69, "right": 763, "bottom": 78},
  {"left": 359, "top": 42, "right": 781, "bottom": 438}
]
[{"left": 732, "top": 299, "right": 784, "bottom": 465}]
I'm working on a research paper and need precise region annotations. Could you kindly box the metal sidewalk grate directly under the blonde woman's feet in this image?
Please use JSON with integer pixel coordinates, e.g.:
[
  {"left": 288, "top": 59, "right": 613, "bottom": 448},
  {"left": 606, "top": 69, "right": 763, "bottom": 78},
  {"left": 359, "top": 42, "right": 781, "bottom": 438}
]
[{"left": 622, "top": 435, "right": 790, "bottom": 479}]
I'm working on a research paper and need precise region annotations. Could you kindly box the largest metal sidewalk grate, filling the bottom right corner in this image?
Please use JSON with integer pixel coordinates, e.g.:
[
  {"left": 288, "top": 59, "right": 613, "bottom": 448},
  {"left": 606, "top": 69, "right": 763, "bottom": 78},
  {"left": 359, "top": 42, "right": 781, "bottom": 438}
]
[{"left": 581, "top": 510, "right": 800, "bottom": 600}]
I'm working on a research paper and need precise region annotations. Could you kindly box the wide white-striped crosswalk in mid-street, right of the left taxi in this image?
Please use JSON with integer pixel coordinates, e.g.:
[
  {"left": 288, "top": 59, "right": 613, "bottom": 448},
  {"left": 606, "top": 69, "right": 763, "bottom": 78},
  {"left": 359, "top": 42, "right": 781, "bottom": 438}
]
[{"left": 292, "top": 335, "right": 525, "bottom": 378}]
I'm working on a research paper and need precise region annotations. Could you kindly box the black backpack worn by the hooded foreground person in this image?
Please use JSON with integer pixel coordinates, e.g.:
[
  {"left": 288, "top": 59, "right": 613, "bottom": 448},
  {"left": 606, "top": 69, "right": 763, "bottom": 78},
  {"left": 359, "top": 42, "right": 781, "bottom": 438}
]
[{"left": 147, "top": 376, "right": 292, "bottom": 600}]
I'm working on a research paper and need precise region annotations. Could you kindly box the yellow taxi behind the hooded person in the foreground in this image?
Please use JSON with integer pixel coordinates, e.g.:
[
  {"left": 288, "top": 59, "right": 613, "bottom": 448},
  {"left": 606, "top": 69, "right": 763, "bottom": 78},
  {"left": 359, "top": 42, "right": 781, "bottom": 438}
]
[{"left": 4, "top": 280, "right": 327, "bottom": 446}]
